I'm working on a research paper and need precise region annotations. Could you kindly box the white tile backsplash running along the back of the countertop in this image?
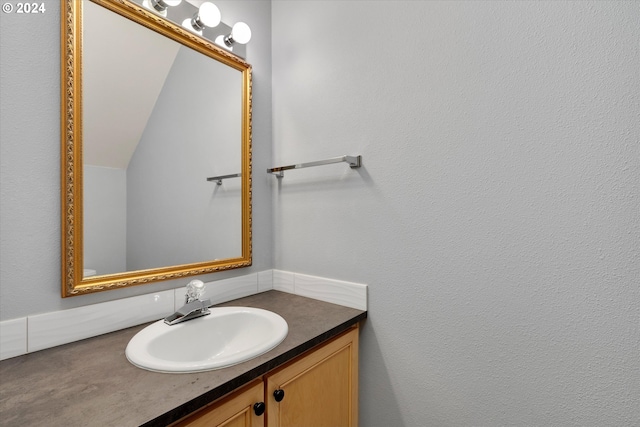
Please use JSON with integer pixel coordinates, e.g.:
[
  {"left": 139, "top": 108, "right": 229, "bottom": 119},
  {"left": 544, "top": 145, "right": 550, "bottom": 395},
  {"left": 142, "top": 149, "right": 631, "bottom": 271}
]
[{"left": 0, "top": 270, "right": 367, "bottom": 360}]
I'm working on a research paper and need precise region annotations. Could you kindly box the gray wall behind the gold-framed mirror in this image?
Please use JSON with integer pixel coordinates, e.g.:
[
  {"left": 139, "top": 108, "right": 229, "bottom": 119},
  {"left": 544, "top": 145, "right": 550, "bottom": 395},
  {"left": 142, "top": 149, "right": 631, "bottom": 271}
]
[{"left": 0, "top": 0, "right": 273, "bottom": 320}]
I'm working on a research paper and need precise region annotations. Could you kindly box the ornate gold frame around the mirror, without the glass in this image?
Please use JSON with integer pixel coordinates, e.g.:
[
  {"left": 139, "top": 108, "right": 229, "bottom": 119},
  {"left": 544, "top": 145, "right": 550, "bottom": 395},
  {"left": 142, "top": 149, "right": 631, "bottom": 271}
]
[{"left": 61, "top": 0, "right": 252, "bottom": 297}]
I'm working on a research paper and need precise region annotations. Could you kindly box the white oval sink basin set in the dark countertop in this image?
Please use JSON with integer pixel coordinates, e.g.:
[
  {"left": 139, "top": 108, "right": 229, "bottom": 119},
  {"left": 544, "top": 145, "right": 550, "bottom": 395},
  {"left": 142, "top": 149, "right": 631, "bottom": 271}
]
[{"left": 125, "top": 307, "right": 289, "bottom": 373}]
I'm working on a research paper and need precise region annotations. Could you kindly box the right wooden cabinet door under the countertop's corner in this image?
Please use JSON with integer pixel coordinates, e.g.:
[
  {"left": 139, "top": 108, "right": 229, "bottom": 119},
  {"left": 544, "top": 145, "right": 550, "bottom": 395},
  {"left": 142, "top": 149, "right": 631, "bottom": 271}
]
[{"left": 266, "top": 328, "right": 358, "bottom": 427}]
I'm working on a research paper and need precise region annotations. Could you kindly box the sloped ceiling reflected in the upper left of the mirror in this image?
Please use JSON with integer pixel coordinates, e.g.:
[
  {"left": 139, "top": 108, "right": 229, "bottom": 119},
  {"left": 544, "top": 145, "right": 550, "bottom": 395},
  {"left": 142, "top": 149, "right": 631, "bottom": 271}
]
[{"left": 82, "top": 1, "right": 180, "bottom": 169}]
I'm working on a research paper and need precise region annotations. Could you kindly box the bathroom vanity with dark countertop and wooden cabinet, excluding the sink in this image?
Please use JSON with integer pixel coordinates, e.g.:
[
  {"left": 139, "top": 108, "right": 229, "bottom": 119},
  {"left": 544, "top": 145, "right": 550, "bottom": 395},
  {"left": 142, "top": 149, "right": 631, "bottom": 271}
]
[{"left": 0, "top": 291, "right": 367, "bottom": 427}]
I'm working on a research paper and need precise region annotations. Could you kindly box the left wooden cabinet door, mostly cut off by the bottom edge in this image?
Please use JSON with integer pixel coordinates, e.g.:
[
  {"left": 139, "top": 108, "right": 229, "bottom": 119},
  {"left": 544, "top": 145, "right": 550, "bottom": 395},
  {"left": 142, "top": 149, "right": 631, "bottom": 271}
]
[{"left": 175, "top": 380, "right": 265, "bottom": 427}]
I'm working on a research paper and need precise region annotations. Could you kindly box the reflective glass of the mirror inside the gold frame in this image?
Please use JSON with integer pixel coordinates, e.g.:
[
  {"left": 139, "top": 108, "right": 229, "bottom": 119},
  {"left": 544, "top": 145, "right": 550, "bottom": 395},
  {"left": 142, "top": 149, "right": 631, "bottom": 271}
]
[{"left": 82, "top": 3, "right": 242, "bottom": 274}]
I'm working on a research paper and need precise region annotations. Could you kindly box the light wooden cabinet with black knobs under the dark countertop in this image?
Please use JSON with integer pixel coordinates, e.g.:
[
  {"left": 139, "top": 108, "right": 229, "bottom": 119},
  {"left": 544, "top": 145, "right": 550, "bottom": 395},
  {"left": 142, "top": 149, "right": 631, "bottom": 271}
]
[{"left": 174, "top": 326, "right": 358, "bottom": 427}]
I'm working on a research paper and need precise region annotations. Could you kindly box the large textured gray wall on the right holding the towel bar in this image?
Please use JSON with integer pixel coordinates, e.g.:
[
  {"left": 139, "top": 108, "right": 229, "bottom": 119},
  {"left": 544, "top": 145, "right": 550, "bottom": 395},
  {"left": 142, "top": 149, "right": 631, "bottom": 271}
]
[{"left": 272, "top": 0, "right": 640, "bottom": 427}]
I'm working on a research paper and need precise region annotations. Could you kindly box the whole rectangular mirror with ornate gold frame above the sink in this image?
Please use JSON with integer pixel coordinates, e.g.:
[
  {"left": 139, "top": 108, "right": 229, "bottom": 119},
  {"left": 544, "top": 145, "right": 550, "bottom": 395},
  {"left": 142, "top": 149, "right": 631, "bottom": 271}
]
[{"left": 61, "top": 0, "right": 252, "bottom": 297}]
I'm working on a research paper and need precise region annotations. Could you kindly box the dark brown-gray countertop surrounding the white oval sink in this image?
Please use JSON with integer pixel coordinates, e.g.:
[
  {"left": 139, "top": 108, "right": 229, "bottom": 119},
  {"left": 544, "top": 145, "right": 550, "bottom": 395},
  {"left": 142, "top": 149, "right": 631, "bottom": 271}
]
[{"left": 0, "top": 291, "right": 367, "bottom": 427}]
